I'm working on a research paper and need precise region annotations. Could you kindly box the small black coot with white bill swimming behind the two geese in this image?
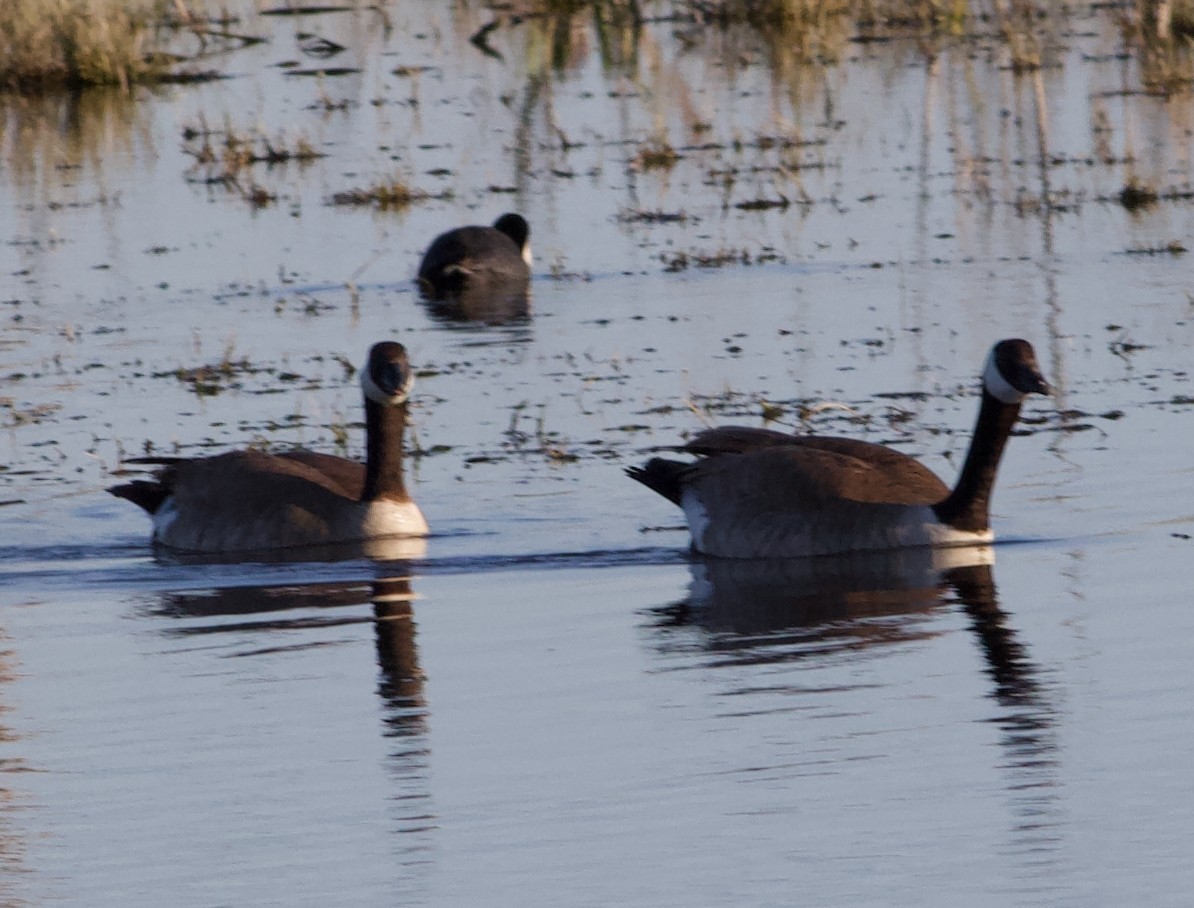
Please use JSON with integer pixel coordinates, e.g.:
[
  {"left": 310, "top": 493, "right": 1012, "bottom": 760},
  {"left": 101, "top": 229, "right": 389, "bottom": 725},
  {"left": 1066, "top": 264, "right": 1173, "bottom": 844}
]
[{"left": 419, "top": 214, "right": 531, "bottom": 294}]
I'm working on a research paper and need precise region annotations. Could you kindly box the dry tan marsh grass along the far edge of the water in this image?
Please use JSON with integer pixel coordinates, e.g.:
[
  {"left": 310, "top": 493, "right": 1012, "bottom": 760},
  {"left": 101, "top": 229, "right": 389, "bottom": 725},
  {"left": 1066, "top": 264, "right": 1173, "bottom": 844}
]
[{"left": 0, "top": 0, "right": 1194, "bottom": 93}]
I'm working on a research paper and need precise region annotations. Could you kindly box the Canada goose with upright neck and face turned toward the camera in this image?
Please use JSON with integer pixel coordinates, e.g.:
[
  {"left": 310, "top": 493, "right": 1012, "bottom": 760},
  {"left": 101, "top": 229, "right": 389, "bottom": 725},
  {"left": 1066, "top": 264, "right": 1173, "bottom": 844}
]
[{"left": 107, "top": 342, "right": 427, "bottom": 553}]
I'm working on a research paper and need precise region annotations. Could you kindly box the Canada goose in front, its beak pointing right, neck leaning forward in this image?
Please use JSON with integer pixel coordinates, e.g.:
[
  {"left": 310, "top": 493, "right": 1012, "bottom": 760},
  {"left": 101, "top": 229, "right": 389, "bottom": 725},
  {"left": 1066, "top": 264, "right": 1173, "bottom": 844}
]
[{"left": 626, "top": 339, "right": 1050, "bottom": 558}]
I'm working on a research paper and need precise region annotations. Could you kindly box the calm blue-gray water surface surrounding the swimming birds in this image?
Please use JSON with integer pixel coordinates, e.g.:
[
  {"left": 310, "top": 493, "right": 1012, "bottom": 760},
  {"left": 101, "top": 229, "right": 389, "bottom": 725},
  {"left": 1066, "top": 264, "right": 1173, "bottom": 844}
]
[{"left": 0, "top": 2, "right": 1194, "bottom": 907}]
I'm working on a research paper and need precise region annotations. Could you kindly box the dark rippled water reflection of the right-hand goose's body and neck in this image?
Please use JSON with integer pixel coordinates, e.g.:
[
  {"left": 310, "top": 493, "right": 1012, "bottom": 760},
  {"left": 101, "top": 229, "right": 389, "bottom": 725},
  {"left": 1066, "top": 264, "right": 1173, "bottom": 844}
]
[{"left": 646, "top": 546, "right": 1060, "bottom": 852}]
